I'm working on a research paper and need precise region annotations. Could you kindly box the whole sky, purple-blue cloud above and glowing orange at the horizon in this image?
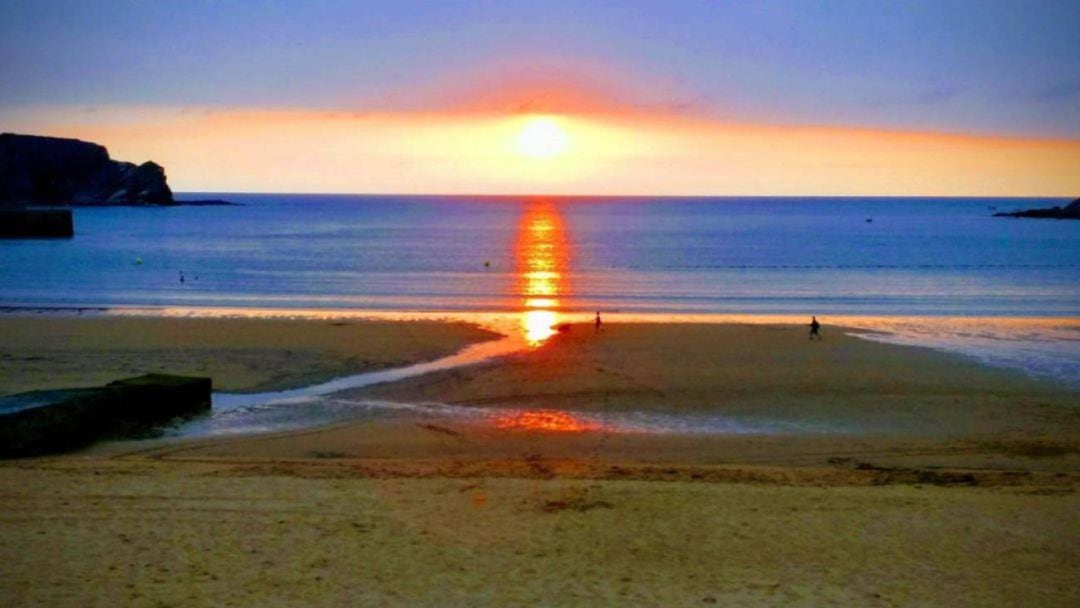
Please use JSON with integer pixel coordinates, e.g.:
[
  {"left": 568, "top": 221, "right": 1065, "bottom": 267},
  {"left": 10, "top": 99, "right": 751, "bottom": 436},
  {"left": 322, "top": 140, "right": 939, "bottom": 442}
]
[{"left": 0, "top": 0, "right": 1080, "bottom": 197}]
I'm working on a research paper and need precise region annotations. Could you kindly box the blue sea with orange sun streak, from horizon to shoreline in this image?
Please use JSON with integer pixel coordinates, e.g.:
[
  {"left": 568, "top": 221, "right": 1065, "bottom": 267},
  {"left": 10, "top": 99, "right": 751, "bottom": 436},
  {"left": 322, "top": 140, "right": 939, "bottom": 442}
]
[{"left": 0, "top": 192, "right": 1080, "bottom": 395}]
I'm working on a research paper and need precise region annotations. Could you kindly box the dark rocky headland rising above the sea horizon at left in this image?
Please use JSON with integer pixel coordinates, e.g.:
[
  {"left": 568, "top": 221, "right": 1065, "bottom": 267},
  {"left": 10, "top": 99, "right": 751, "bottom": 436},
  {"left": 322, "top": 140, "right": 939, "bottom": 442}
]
[{"left": 0, "top": 133, "right": 173, "bottom": 206}]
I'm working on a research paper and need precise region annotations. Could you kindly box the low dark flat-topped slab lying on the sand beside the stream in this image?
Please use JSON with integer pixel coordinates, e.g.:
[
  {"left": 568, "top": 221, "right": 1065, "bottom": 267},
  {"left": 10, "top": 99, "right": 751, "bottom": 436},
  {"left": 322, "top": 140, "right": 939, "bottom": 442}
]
[{"left": 0, "top": 374, "right": 211, "bottom": 458}]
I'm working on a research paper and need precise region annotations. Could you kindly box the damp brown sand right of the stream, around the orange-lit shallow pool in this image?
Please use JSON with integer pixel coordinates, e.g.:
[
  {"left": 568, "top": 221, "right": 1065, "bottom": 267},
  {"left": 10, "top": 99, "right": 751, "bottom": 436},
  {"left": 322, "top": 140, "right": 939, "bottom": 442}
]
[{"left": 159, "top": 324, "right": 1080, "bottom": 472}]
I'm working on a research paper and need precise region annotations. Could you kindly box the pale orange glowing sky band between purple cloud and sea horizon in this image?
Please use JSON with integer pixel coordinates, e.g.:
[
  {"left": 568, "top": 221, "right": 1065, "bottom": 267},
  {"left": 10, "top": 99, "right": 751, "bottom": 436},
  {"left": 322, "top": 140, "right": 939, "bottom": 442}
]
[{"left": 4, "top": 103, "right": 1080, "bottom": 197}]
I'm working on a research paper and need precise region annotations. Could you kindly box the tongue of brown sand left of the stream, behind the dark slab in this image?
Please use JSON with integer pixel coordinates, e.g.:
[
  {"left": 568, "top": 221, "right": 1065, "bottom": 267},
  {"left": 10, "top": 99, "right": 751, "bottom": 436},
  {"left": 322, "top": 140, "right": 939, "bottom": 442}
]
[{"left": 0, "top": 315, "right": 496, "bottom": 394}]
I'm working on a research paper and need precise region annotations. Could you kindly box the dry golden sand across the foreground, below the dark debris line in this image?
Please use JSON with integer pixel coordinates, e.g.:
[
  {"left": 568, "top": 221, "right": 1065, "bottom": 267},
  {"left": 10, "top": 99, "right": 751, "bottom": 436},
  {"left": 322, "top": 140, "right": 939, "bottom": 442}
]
[{"left": 0, "top": 459, "right": 1080, "bottom": 607}]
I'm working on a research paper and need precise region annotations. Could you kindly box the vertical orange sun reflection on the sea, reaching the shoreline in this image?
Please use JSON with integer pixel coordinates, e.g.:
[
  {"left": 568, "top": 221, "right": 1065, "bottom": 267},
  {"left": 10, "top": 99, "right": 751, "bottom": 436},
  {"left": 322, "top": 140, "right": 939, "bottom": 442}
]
[{"left": 514, "top": 200, "right": 569, "bottom": 347}]
